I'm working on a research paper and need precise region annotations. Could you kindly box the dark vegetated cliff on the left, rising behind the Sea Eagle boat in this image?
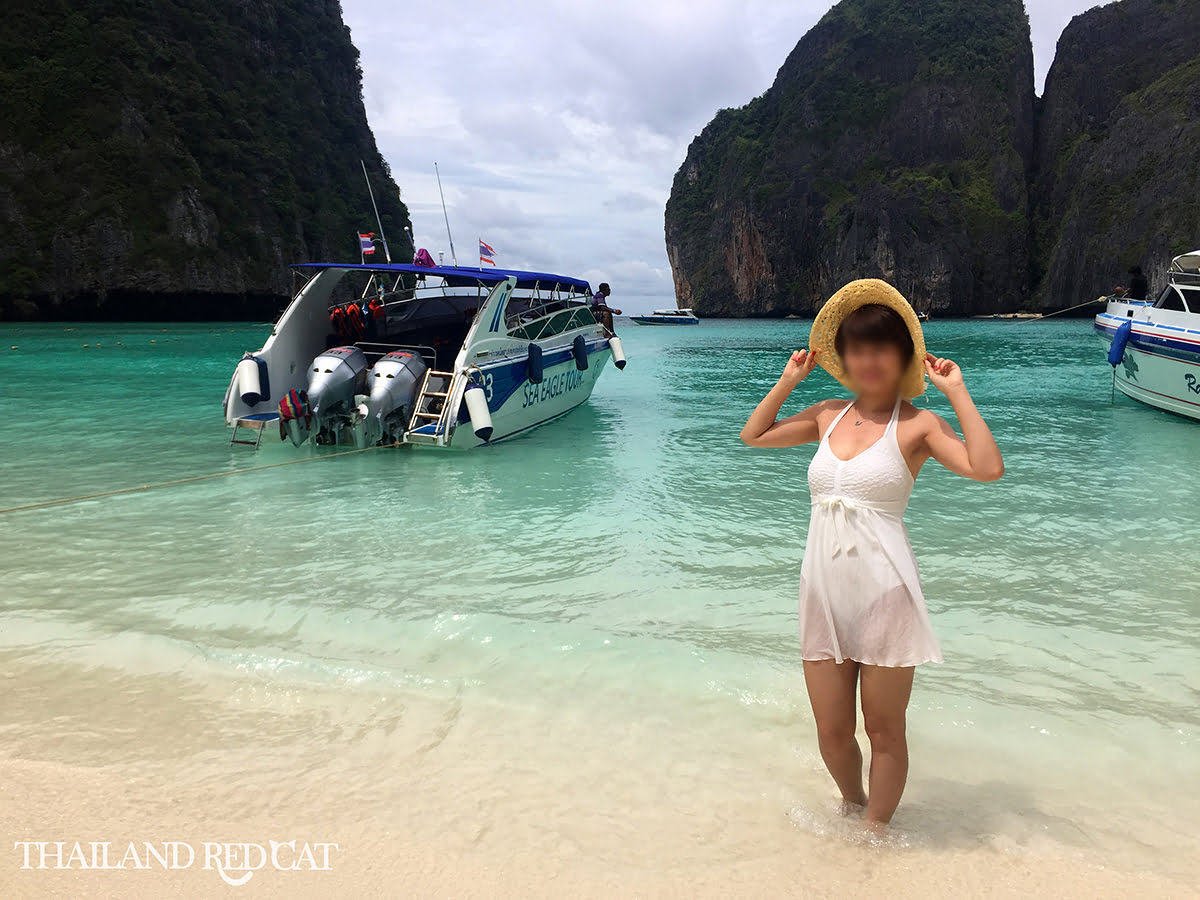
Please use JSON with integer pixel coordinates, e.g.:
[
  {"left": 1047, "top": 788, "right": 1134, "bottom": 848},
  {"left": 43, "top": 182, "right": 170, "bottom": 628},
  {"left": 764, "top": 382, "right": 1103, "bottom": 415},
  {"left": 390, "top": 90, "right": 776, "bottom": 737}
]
[{"left": 0, "top": 0, "right": 410, "bottom": 318}]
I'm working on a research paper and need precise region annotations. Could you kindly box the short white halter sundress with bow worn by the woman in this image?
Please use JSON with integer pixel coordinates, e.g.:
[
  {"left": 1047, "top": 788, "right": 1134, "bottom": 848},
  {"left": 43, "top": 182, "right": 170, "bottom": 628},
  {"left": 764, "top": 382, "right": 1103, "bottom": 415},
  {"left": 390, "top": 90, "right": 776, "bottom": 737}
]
[{"left": 800, "top": 401, "right": 942, "bottom": 666}]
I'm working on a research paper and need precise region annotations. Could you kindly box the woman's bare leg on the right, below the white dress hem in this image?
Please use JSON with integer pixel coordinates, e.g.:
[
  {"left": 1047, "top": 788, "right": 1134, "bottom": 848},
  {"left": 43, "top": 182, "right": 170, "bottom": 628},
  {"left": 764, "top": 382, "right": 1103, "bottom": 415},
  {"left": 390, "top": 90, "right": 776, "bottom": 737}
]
[{"left": 859, "top": 666, "right": 913, "bottom": 824}]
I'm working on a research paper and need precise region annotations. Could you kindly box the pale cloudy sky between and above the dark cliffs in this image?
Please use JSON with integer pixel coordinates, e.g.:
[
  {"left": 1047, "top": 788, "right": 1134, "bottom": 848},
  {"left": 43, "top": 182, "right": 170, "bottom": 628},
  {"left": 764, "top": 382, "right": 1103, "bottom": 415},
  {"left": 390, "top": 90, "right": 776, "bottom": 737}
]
[{"left": 342, "top": 0, "right": 1097, "bottom": 312}]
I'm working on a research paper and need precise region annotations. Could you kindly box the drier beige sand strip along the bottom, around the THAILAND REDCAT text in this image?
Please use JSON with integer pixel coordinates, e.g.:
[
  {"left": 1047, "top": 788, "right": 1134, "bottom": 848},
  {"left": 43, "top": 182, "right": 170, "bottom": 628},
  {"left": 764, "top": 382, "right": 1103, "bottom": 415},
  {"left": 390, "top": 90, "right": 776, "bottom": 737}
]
[{"left": 0, "top": 761, "right": 1200, "bottom": 900}]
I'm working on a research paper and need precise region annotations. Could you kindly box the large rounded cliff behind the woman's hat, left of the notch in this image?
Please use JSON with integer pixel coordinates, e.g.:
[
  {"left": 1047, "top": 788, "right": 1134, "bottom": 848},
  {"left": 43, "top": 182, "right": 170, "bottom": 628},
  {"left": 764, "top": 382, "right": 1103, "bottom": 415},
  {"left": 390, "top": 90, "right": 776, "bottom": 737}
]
[{"left": 666, "top": 0, "right": 1034, "bottom": 316}]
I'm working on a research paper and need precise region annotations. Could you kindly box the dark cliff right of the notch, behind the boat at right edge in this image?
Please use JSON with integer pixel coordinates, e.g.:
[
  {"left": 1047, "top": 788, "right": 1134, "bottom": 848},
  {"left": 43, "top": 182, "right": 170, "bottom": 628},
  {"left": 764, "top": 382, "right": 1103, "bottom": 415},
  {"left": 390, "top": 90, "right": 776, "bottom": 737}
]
[{"left": 1033, "top": 0, "right": 1200, "bottom": 308}]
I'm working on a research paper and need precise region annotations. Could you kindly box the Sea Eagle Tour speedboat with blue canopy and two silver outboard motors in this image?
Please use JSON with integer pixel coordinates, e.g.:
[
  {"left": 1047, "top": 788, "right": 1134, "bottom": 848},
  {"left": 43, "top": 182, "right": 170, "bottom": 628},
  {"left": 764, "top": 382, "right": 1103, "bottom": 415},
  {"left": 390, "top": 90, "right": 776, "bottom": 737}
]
[{"left": 224, "top": 263, "right": 625, "bottom": 448}]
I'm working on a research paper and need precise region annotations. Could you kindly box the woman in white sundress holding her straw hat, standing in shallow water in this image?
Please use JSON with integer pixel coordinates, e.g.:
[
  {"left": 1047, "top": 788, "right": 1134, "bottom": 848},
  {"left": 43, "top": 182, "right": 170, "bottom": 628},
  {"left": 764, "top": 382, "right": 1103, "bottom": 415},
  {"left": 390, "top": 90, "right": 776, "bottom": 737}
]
[{"left": 742, "top": 278, "right": 1004, "bottom": 828}]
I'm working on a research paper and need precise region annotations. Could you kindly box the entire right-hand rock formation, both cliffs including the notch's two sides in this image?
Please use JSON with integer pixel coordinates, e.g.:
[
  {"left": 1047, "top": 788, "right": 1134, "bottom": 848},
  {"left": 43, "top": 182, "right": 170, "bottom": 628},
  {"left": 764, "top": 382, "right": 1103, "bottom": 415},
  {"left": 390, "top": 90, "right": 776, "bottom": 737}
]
[{"left": 666, "top": 0, "right": 1200, "bottom": 316}]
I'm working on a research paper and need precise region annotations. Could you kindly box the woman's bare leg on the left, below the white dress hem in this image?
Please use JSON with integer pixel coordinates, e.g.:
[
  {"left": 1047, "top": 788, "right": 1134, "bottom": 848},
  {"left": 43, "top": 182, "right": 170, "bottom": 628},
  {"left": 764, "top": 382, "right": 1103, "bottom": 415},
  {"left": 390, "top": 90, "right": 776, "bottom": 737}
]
[{"left": 804, "top": 659, "right": 866, "bottom": 806}]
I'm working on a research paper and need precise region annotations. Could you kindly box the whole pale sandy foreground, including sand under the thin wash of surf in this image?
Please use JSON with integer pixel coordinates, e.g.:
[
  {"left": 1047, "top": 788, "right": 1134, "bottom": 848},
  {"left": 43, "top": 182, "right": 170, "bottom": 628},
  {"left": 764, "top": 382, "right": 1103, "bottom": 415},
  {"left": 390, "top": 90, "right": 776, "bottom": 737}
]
[{"left": 0, "top": 662, "right": 1200, "bottom": 899}]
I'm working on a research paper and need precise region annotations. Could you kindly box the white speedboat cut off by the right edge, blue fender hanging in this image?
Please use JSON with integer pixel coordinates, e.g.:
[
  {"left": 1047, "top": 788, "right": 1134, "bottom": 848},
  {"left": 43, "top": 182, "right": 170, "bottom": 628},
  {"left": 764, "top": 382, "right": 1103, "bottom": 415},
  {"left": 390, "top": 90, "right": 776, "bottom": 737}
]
[{"left": 1094, "top": 250, "right": 1200, "bottom": 419}]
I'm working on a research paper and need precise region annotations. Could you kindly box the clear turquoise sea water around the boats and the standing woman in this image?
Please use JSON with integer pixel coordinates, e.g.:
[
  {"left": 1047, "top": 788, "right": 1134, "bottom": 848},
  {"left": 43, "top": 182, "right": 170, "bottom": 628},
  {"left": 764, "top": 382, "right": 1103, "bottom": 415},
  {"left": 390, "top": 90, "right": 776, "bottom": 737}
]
[{"left": 0, "top": 320, "right": 1200, "bottom": 875}]
